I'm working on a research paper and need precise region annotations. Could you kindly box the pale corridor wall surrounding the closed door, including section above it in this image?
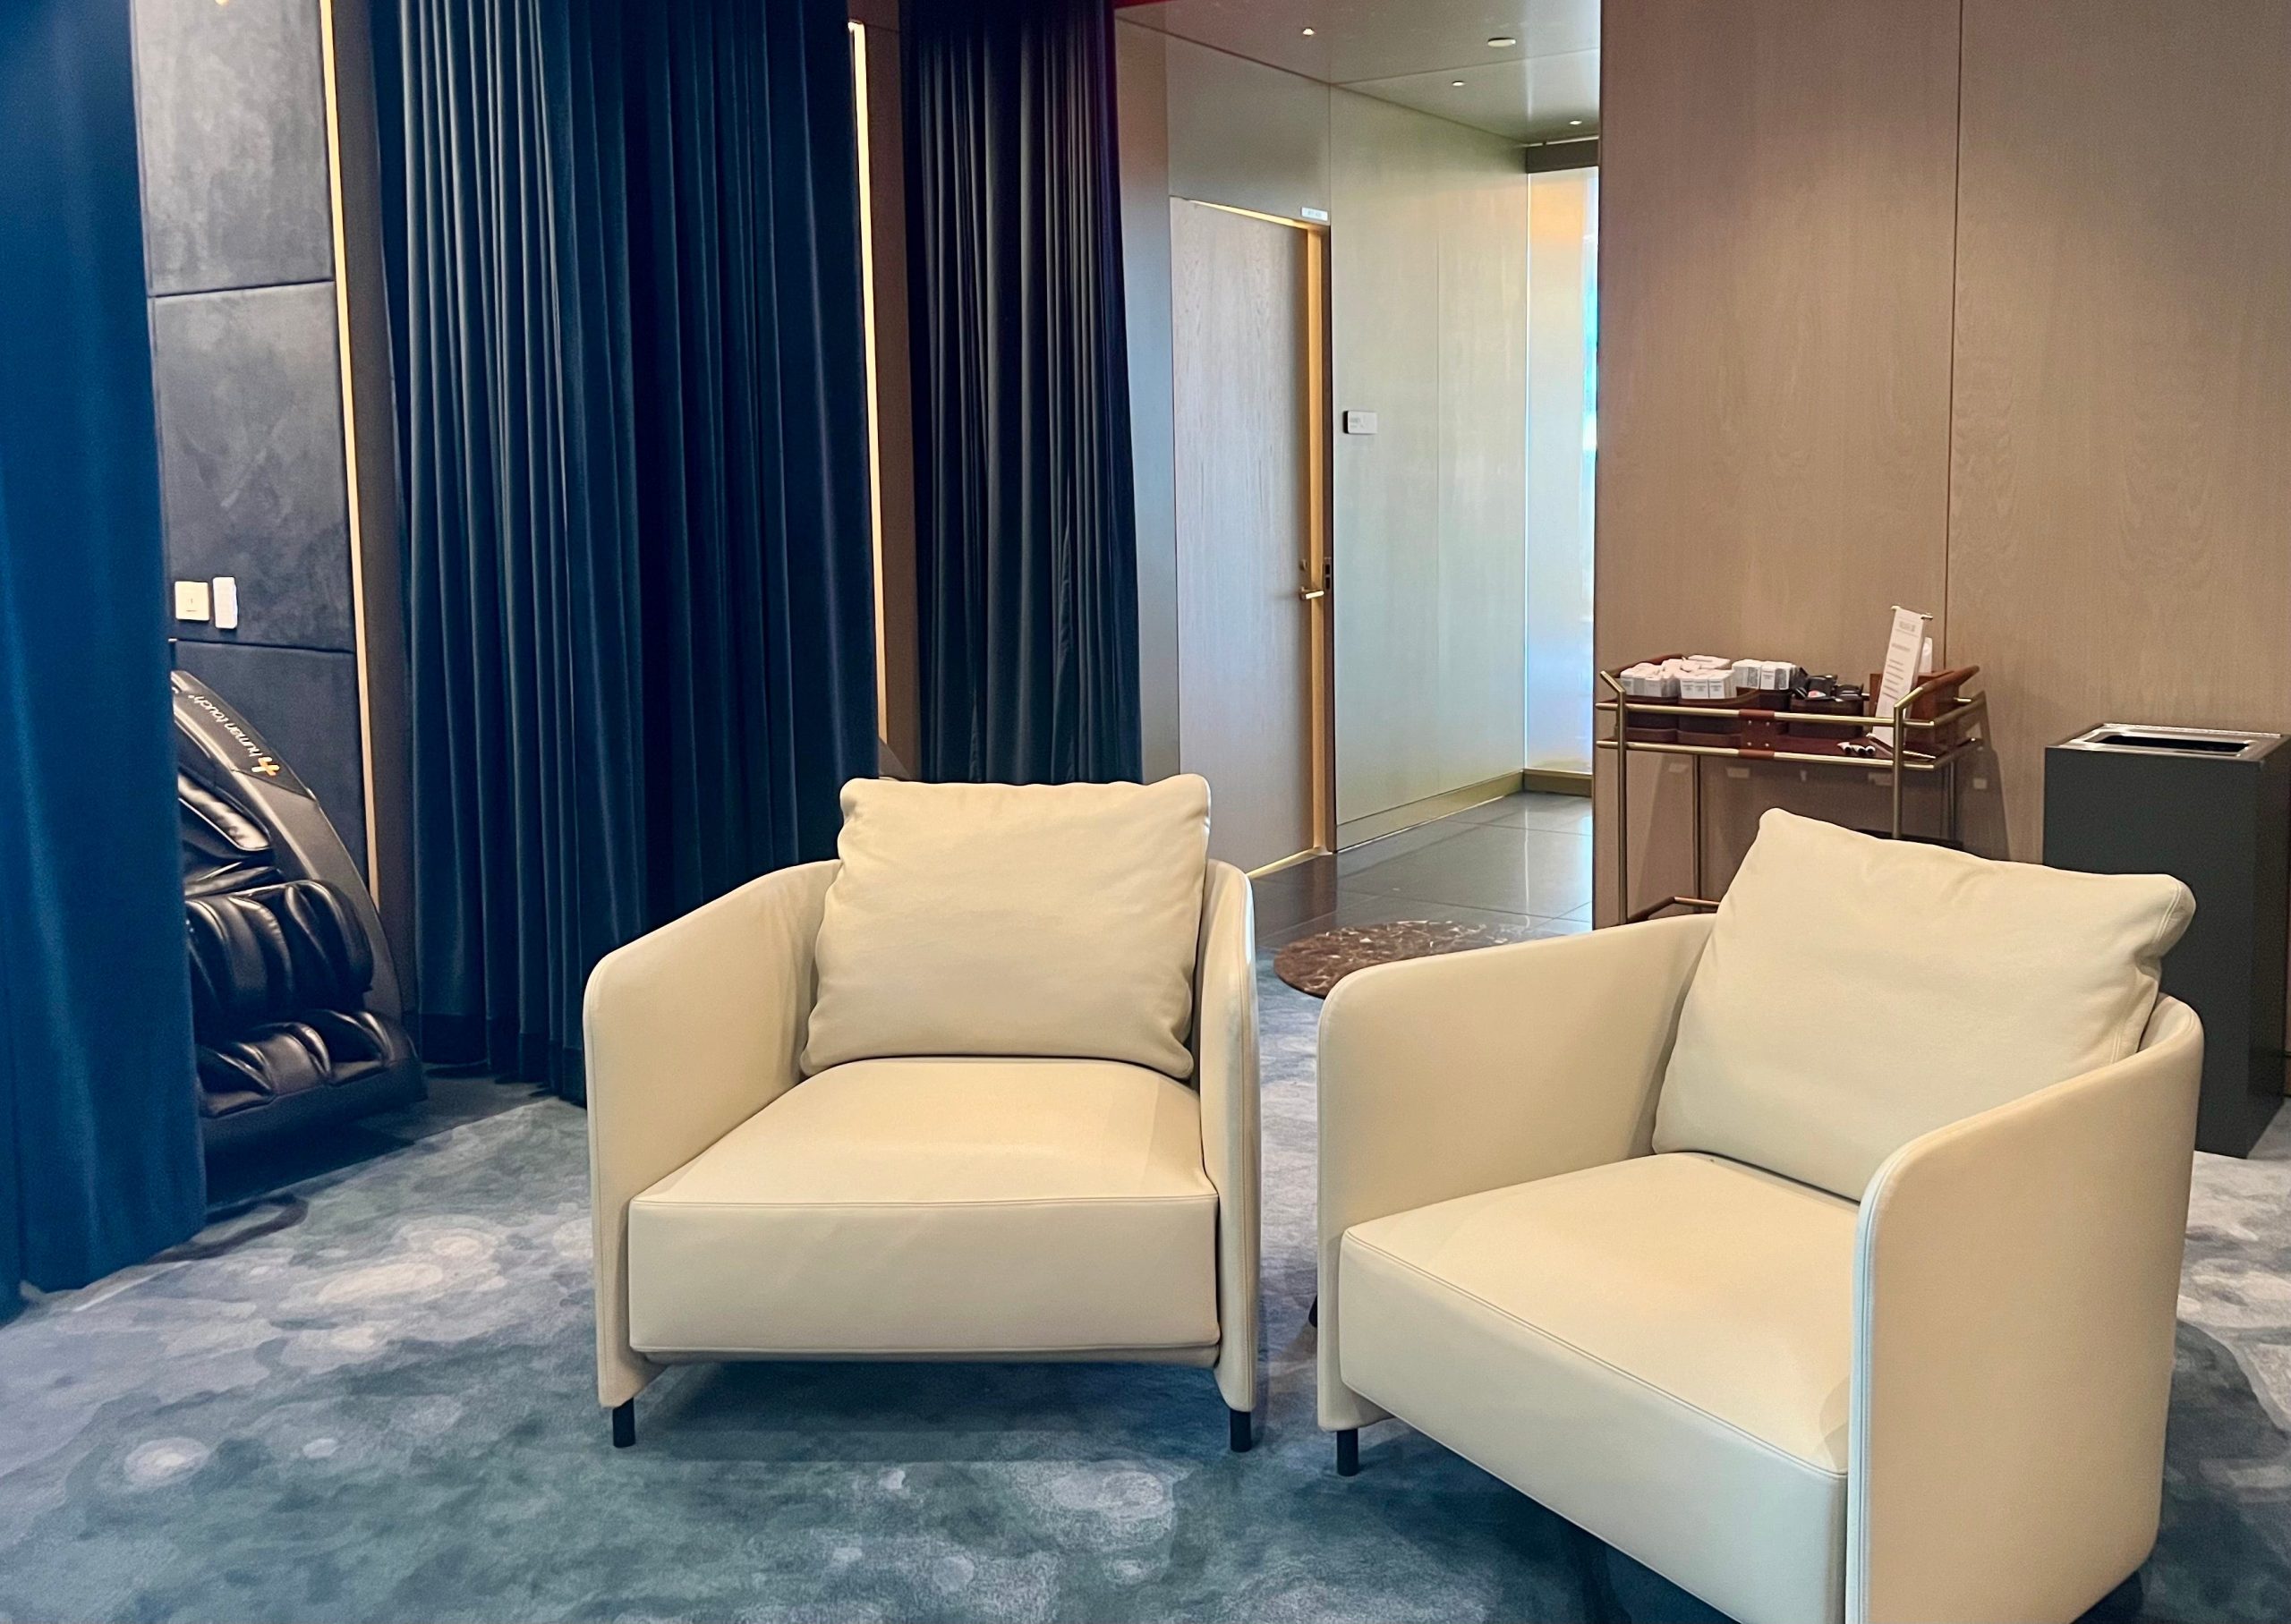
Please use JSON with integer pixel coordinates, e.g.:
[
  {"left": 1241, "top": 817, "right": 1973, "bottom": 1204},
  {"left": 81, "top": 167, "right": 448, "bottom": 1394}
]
[{"left": 1116, "top": 23, "right": 1526, "bottom": 820}]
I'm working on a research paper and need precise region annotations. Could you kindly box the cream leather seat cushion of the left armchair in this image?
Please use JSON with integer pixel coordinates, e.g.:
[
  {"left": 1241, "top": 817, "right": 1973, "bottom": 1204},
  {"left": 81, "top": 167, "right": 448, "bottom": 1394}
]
[{"left": 627, "top": 1059, "right": 1219, "bottom": 1358}]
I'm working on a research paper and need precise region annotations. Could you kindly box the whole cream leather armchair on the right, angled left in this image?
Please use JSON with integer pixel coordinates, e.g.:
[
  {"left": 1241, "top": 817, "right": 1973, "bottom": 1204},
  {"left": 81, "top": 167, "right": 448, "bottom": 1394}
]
[{"left": 1320, "top": 813, "right": 2202, "bottom": 1624}]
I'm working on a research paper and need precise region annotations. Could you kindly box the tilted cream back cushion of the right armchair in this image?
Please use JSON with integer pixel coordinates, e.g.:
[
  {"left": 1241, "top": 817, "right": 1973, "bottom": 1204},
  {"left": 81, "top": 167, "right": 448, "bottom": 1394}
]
[{"left": 1654, "top": 811, "right": 2194, "bottom": 1200}]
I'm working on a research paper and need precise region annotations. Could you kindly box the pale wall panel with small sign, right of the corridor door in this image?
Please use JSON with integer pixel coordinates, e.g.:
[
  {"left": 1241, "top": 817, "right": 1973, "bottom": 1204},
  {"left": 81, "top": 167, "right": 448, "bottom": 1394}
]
[{"left": 1329, "top": 89, "right": 1529, "bottom": 829}]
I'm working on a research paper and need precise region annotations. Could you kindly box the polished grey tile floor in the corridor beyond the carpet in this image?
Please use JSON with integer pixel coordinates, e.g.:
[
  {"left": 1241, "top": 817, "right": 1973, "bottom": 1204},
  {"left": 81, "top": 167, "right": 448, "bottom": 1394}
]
[{"left": 1256, "top": 795, "right": 1590, "bottom": 948}]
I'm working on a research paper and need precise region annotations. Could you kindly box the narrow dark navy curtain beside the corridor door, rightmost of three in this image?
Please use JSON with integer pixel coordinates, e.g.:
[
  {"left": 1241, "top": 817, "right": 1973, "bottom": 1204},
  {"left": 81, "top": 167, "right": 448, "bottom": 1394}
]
[{"left": 900, "top": 0, "right": 1141, "bottom": 784}]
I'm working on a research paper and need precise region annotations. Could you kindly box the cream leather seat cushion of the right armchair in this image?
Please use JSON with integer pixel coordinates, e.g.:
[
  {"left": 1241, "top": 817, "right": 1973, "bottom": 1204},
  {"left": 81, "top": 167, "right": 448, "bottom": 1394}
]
[{"left": 1338, "top": 1154, "right": 1858, "bottom": 1624}]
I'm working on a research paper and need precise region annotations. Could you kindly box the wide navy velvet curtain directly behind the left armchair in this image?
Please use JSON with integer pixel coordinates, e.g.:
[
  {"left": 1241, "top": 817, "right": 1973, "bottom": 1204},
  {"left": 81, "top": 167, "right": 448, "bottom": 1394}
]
[{"left": 376, "top": 0, "right": 875, "bottom": 1095}]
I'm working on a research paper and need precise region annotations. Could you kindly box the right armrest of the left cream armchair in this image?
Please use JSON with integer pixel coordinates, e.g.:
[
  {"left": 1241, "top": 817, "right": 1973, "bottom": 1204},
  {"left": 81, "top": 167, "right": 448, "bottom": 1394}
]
[{"left": 1194, "top": 863, "right": 1263, "bottom": 1413}]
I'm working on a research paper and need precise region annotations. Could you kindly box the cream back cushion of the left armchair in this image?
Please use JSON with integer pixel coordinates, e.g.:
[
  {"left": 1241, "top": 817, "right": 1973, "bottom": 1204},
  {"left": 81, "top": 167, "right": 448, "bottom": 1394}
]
[{"left": 805, "top": 774, "right": 1210, "bottom": 1079}]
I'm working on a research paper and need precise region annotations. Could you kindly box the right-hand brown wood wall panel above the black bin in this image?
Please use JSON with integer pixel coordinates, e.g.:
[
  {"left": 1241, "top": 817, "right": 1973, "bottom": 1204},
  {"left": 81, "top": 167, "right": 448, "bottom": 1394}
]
[{"left": 1950, "top": 0, "right": 2291, "bottom": 859}]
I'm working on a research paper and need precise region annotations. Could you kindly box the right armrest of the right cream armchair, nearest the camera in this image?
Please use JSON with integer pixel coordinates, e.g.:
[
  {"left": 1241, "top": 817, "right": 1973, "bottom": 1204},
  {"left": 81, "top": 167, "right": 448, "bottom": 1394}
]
[{"left": 1846, "top": 999, "right": 2204, "bottom": 1624}]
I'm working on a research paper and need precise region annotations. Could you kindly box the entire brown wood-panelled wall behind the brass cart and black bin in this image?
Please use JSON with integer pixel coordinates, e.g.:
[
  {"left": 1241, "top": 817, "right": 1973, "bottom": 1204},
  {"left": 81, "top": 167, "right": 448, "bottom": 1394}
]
[{"left": 1597, "top": 0, "right": 2291, "bottom": 916}]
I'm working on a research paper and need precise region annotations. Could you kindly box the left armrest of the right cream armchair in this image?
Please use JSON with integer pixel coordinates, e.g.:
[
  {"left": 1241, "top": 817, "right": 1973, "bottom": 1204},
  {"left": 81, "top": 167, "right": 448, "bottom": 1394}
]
[{"left": 1320, "top": 914, "right": 1711, "bottom": 1432}]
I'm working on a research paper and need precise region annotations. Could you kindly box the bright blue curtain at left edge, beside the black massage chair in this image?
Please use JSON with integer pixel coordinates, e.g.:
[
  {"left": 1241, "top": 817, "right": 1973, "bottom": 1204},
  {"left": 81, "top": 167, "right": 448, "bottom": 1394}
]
[{"left": 0, "top": 0, "right": 206, "bottom": 1320}]
